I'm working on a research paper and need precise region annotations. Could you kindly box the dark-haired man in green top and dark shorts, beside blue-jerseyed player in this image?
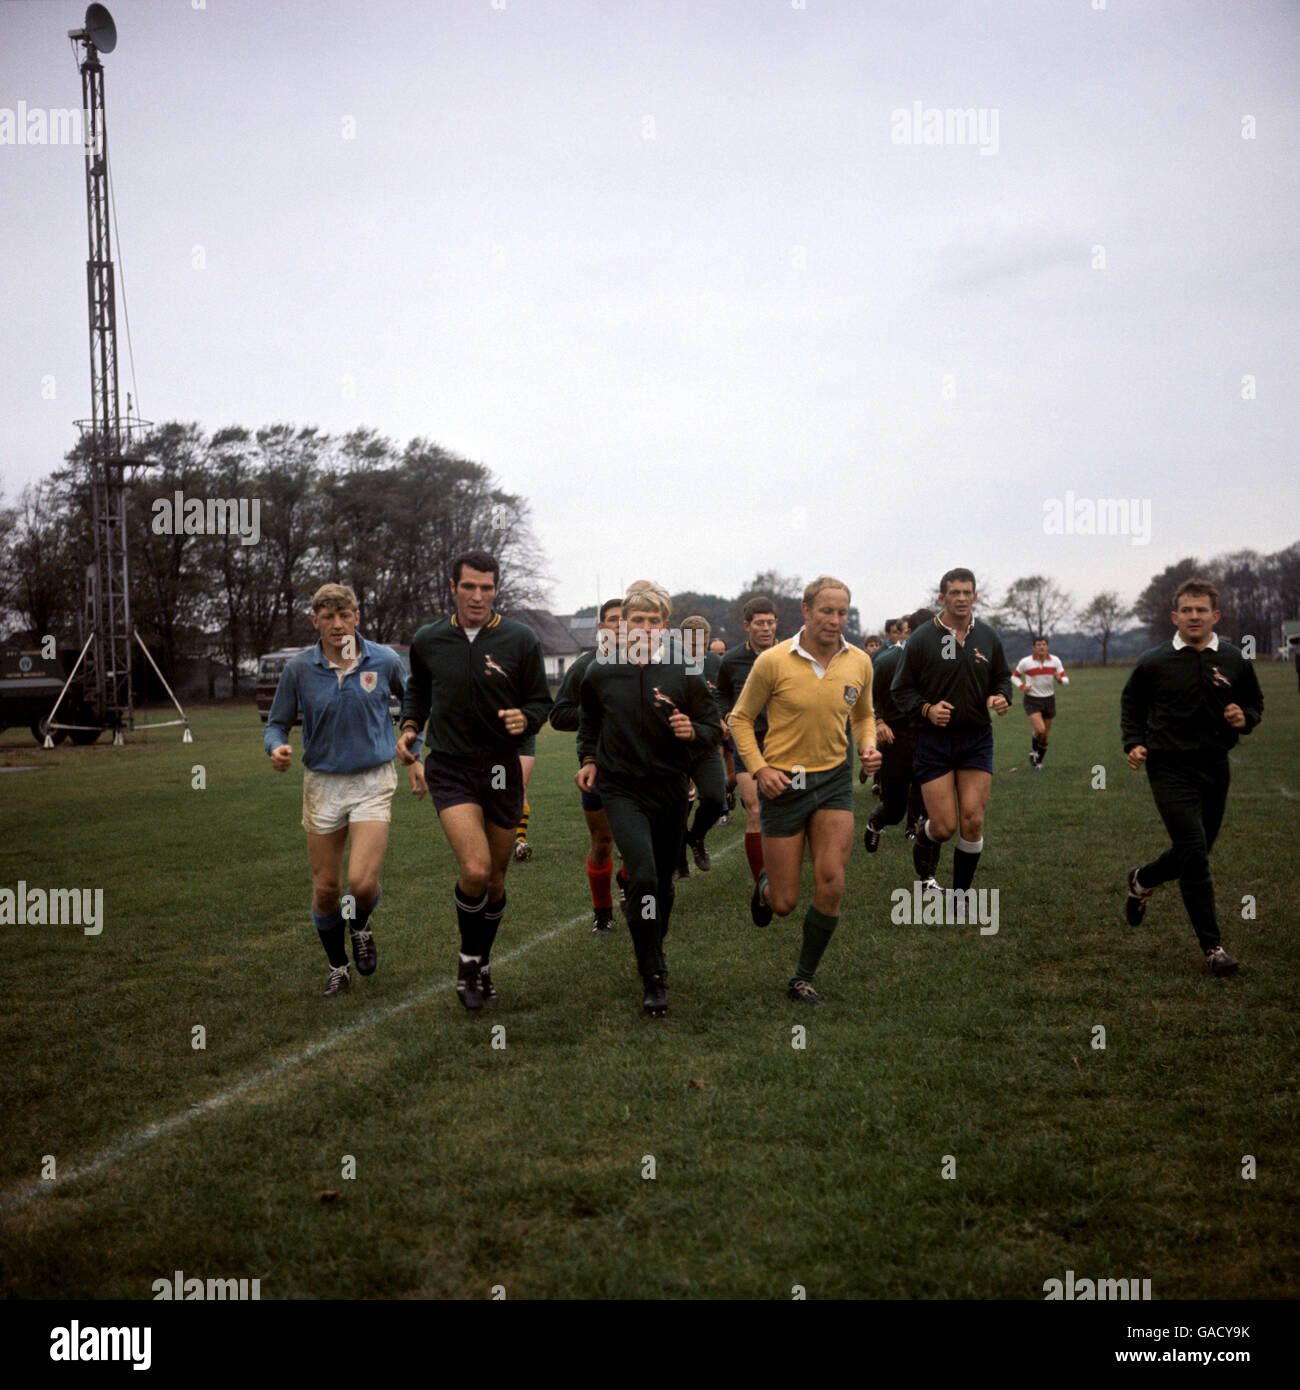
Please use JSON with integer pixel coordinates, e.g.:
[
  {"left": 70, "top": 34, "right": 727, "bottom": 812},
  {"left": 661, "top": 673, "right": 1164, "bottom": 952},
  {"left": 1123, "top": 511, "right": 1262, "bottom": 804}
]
[{"left": 398, "top": 550, "right": 551, "bottom": 1011}]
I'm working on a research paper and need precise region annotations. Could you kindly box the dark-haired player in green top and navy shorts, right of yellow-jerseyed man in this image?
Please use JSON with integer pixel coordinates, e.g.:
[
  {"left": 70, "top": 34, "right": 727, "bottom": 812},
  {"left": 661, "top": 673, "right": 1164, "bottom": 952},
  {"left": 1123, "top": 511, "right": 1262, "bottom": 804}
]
[{"left": 891, "top": 569, "right": 1011, "bottom": 891}]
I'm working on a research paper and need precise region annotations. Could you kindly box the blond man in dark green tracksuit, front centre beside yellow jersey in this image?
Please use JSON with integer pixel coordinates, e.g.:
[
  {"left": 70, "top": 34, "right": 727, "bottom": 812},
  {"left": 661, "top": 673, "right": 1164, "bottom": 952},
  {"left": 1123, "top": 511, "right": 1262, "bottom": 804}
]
[{"left": 576, "top": 582, "right": 722, "bottom": 1017}]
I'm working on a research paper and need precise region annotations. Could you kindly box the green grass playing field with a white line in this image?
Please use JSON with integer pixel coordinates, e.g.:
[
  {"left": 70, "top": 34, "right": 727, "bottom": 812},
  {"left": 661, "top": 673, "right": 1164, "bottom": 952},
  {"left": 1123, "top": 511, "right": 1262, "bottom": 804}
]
[{"left": 0, "top": 663, "right": 1300, "bottom": 1300}]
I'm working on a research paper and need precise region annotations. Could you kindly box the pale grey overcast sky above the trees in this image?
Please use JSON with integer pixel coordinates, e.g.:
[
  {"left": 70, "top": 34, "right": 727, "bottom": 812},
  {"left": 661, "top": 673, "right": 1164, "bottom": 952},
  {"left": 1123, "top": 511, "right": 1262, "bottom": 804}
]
[{"left": 0, "top": 0, "right": 1300, "bottom": 627}]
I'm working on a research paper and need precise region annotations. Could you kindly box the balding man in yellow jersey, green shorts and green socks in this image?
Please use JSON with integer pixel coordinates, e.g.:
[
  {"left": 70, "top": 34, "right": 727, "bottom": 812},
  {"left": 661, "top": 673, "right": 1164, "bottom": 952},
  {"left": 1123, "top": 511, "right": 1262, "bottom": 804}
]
[{"left": 730, "top": 574, "right": 880, "bottom": 1005}]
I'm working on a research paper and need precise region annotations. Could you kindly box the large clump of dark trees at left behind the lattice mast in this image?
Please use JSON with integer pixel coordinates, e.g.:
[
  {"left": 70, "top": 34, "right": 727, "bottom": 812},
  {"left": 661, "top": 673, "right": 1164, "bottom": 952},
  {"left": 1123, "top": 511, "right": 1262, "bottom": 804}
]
[{"left": 0, "top": 423, "right": 546, "bottom": 681}]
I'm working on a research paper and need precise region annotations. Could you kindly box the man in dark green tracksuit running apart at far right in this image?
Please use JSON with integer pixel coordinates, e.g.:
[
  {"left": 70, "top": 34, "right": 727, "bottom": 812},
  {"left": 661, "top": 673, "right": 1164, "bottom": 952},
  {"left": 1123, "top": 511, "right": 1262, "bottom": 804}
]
[{"left": 1121, "top": 580, "right": 1264, "bottom": 974}]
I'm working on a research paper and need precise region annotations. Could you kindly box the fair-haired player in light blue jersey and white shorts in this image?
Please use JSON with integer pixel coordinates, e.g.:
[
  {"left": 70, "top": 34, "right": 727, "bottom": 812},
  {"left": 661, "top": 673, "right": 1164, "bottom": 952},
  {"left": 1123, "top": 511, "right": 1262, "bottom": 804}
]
[{"left": 263, "top": 584, "right": 424, "bottom": 998}]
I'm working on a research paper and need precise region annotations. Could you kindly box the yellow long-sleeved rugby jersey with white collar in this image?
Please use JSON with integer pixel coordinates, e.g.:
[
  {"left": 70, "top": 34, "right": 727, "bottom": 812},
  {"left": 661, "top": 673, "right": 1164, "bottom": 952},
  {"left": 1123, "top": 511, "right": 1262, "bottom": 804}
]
[{"left": 727, "top": 628, "right": 876, "bottom": 773}]
